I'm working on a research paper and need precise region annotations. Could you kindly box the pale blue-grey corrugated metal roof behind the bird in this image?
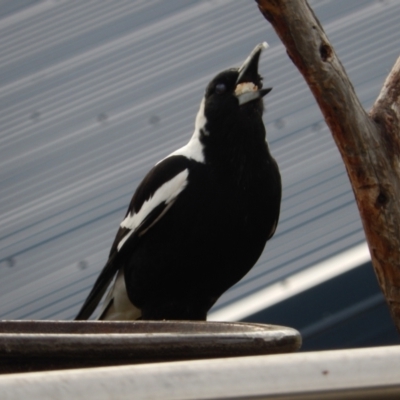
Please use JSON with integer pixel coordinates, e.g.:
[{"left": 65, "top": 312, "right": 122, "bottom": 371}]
[{"left": 0, "top": 0, "right": 400, "bottom": 319}]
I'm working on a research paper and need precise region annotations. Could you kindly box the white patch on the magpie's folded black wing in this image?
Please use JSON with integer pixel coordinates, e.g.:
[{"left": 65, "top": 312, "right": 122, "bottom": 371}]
[{"left": 117, "top": 169, "right": 189, "bottom": 251}]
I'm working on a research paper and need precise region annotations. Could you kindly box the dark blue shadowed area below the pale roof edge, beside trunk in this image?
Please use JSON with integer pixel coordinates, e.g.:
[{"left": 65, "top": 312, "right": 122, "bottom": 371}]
[{"left": 244, "top": 262, "right": 400, "bottom": 351}]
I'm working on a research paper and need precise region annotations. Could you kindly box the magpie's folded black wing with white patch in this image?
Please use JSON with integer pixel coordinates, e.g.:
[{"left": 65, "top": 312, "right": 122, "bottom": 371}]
[{"left": 75, "top": 156, "right": 190, "bottom": 320}]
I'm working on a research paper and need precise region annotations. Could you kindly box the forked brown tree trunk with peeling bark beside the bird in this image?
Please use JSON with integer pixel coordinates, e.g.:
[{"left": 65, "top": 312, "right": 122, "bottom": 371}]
[{"left": 256, "top": 0, "right": 400, "bottom": 331}]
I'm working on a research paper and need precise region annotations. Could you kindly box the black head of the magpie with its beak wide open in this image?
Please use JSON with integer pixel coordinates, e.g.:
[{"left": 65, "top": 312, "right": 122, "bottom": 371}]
[{"left": 198, "top": 42, "right": 272, "bottom": 134}]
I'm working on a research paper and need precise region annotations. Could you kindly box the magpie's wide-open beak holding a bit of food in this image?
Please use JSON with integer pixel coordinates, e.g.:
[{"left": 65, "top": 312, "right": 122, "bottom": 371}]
[{"left": 235, "top": 42, "right": 272, "bottom": 105}]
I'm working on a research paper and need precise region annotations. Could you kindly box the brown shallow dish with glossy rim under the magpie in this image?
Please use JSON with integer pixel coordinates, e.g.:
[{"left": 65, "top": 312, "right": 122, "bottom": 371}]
[{"left": 0, "top": 321, "right": 301, "bottom": 373}]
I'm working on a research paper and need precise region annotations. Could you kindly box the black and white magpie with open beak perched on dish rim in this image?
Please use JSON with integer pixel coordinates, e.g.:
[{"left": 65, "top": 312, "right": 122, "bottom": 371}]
[{"left": 76, "top": 43, "right": 281, "bottom": 320}]
